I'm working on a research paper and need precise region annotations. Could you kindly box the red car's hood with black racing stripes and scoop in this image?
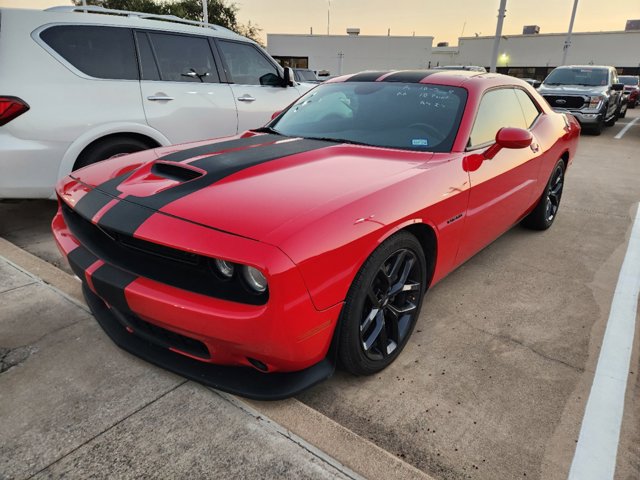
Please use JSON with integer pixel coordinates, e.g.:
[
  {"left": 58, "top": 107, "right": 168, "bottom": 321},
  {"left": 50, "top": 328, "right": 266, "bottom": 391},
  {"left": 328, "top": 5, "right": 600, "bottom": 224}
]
[{"left": 74, "top": 135, "right": 434, "bottom": 243}]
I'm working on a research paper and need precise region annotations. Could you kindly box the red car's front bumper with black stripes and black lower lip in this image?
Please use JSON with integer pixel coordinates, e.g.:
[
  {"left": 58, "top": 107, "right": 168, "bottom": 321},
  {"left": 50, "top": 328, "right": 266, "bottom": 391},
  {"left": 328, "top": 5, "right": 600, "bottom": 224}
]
[{"left": 52, "top": 189, "right": 342, "bottom": 399}]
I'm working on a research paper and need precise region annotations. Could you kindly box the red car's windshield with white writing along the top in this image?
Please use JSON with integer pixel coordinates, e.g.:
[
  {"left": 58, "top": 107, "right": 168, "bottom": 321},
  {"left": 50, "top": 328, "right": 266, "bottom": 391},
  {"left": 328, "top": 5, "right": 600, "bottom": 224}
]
[{"left": 269, "top": 82, "right": 467, "bottom": 152}]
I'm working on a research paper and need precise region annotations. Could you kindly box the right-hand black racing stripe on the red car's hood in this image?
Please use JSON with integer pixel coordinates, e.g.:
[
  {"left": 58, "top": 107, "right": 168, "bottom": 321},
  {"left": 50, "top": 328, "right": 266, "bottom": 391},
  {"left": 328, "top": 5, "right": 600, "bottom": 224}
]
[{"left": 98, "top": 139, "right": 335, "bottom": 235}]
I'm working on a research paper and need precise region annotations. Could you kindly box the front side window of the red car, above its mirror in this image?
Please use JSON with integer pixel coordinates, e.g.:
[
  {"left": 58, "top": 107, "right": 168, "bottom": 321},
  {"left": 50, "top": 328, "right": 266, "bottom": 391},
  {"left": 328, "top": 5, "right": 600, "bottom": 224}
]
[{"left": 469, "top": 88, "right": 528, "bottom": 147}]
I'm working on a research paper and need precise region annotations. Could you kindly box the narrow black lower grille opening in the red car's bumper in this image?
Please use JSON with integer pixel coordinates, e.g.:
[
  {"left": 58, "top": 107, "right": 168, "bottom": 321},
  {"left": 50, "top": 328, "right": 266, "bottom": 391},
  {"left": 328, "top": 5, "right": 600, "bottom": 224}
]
[{"left": 114, "top": 310, "right": 211, "bottom": 359}]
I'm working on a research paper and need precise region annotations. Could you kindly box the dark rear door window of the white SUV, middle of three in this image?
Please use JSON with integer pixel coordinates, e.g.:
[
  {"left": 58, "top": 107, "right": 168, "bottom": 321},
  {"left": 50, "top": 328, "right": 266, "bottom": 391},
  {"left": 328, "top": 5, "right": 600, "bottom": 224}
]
[{"left": 146, "top": 32, "right": 220, "bottom": 83}]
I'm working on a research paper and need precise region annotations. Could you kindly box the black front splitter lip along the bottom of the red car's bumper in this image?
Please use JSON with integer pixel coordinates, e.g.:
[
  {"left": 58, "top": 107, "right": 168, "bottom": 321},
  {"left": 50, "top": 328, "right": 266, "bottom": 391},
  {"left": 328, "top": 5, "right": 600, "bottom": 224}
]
[{"left": 82, "top": 282, "right": 335, "bottom": 400}]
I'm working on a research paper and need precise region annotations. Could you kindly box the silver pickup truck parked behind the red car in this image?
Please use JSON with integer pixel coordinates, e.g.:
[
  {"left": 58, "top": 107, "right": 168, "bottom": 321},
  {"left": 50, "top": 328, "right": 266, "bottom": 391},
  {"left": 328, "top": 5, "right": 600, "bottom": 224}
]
[{"left": 538, "top": 65, "right": 626, "bottom": 135}]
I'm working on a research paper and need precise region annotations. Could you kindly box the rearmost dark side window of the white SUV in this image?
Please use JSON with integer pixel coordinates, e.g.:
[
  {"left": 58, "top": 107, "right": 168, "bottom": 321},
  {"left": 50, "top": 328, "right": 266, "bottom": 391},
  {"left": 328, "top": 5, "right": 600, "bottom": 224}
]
[{"left": 40, "top": 25, "right": 138, "bottom": 80}]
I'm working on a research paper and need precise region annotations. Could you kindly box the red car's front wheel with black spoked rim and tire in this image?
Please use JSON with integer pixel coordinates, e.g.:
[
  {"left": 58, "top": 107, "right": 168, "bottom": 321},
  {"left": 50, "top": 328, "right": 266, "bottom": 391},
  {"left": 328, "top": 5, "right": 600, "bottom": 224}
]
[{"left": 338, "top": 232, "right": 427, "bottom": 375}]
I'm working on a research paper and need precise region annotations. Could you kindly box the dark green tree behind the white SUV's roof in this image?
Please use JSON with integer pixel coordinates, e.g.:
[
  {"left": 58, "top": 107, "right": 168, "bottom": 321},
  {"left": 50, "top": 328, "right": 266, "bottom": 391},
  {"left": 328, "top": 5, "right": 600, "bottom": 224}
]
[{"left": 71, "top": 0, "right": 262, "bottom": 44}]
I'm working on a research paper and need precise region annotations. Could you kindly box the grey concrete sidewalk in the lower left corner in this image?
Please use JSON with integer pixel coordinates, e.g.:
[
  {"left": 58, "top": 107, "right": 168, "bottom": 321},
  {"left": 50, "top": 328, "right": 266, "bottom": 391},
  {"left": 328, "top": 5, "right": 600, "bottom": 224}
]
[{"left": 0, "top": 257, "right": 359, "bottom": 479}]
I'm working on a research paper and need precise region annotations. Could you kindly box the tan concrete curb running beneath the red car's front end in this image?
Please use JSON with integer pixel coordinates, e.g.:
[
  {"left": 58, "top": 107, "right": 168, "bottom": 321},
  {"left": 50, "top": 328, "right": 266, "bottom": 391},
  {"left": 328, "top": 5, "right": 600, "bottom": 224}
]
[{"left": 0, "top": 237, "right": 434, "bottom": 480}]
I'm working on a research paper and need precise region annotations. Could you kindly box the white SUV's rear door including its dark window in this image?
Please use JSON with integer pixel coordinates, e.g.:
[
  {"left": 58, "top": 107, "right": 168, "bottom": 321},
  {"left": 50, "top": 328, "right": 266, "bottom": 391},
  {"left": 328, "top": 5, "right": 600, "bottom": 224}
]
[{"left": 137, "top": 32, "right": 238, "bottom": 143}]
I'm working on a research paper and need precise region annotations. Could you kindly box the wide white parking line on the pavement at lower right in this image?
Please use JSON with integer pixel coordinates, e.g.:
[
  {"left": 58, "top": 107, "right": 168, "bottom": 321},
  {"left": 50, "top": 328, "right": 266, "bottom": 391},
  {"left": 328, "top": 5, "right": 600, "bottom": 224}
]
[{"left": 569, "top": 204, "right": 640, "bottom": 480}]
